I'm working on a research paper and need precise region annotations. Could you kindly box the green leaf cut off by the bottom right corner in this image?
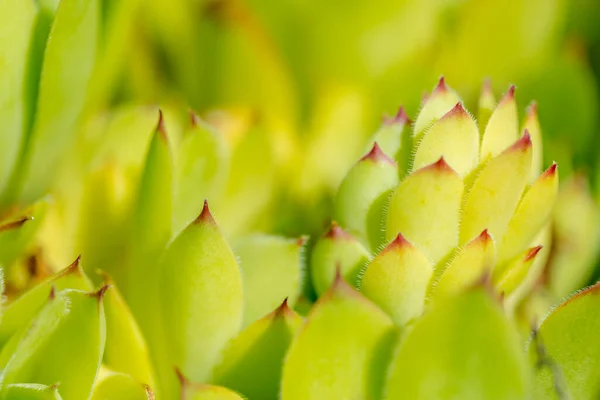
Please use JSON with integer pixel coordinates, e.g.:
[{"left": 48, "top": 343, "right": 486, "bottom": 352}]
[{"left": 529, "top": 284, "right": 600, "bottom": 399}]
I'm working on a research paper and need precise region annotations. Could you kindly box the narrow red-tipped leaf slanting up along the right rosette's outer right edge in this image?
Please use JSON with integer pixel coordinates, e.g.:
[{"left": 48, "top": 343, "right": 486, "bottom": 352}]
[{"left": 498, "top": 164, "right": 558, "bottom": 264}]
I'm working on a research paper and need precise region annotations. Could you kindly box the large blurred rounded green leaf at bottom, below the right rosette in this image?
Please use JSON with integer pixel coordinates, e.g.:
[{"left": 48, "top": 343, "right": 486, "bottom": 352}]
[{"left": 384, "top": 288, "right": 530, "bottom": 400}]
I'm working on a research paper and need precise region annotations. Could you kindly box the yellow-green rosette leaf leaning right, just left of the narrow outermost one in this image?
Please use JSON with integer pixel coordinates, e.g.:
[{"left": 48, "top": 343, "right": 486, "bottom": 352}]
[{"left": 460, "top": 132, "right": 531, "bottom": 245}]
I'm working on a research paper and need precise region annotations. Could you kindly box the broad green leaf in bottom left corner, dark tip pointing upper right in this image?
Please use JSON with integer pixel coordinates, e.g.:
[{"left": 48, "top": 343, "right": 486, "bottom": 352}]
[{"left": 2, "top": 286, "right": 107, "bottom": 400}]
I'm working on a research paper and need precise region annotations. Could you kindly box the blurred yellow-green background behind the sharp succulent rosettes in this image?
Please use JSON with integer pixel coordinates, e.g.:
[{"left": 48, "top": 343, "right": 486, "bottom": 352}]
[{"left": 0, "top": 0, "right": 600, "bottom": 294}]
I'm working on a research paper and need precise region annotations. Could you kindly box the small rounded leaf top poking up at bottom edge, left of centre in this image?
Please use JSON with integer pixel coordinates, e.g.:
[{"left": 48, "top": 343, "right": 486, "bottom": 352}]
[{"left": 91, "top": 372, "right": 154, "bottom": 400}]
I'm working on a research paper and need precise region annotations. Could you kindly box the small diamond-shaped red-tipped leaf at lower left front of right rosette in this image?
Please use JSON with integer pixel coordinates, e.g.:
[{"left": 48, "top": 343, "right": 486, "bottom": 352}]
[{"left": 359, "top": 234, "right": 433, "bottom": 326}]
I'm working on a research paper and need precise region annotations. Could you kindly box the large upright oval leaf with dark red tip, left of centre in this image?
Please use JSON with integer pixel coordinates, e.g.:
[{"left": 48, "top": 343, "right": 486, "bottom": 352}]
[{"left": 160, "top": 202, "right": 243, "bottom": 388}]
